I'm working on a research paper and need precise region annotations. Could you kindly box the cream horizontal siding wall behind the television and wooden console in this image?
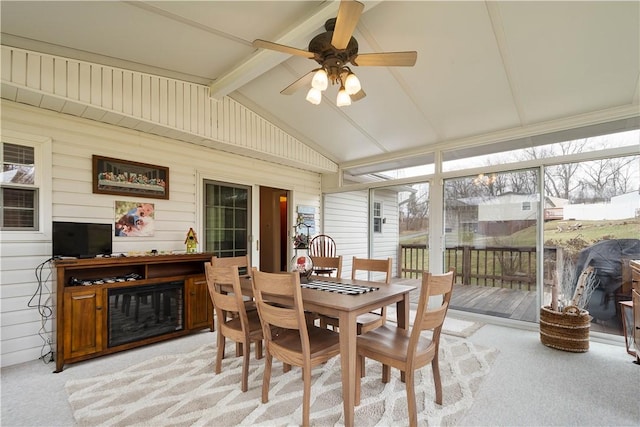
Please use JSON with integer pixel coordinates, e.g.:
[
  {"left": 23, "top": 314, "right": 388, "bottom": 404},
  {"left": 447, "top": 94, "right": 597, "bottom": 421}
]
[{"left": 0, "top": 101, "right": 320, "bottom": 366}]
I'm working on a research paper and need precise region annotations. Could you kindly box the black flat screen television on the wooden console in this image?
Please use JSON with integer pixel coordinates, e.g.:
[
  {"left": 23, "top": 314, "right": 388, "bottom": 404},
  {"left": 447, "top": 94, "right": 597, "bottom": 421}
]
[{"left": 52, "top": 221, "right": 113, "bottom": 258}]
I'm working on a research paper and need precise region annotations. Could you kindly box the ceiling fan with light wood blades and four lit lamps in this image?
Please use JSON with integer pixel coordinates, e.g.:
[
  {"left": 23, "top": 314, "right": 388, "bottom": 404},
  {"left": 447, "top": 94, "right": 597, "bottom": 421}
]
[{"left": 253, "top": 0, "right": 418, "bottom": 107}]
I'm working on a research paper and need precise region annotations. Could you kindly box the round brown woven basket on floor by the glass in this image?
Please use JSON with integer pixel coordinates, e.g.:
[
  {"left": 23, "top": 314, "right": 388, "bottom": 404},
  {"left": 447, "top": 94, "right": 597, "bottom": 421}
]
[{"left": 540, "top": 306, "right": 591, "bottom": 353}]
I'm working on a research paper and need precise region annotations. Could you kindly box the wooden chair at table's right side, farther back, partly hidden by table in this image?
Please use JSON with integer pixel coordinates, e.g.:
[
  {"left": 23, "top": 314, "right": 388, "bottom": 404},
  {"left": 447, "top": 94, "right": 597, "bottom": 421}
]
[{"left": 320, "top": 257, "right": 393, "bottom": 334}]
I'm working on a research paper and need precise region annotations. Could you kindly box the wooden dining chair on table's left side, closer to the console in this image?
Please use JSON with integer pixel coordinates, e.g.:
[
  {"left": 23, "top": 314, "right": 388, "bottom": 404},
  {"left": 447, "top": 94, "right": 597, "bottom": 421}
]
[{"left": 205, "top": 262, "right": 263, "bottom": 392}]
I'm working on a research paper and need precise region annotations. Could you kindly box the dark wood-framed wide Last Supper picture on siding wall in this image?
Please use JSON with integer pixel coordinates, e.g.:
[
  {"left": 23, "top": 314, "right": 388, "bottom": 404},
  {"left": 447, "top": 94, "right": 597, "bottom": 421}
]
[{"left": 93, "top": 155, "right": 169, "bottom": 199}]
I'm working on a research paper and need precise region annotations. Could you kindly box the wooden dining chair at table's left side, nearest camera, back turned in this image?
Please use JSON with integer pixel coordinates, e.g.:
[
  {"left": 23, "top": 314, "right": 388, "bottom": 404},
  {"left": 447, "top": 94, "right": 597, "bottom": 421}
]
[{"left": 252, "top": 267, "right": 340, "bottom": 426}]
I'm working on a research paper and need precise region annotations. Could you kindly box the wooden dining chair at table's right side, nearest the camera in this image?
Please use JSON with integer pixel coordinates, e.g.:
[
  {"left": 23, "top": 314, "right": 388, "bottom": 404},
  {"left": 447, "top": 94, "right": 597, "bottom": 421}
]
[{"left": 355, "top": 269, "right": 455, "bottom": 427}]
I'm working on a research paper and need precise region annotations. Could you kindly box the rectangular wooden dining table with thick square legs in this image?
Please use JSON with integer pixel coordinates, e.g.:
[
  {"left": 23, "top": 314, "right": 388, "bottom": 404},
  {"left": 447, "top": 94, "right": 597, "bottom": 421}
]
[{"left": 235, "top": 276, "right": 416, "bottom": 427}]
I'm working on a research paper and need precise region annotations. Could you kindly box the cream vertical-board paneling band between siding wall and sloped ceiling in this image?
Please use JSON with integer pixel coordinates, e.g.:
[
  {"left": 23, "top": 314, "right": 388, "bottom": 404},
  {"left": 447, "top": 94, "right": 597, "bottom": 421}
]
[{"left": 2, "top": 46, "right": 336, "bottom": 172}]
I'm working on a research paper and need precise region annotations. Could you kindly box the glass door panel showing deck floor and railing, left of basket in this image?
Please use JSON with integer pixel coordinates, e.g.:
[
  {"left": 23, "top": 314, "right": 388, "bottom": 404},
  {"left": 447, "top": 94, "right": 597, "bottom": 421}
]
[{"left": 444, "top": 169, "right": 541, "bottom": 322}]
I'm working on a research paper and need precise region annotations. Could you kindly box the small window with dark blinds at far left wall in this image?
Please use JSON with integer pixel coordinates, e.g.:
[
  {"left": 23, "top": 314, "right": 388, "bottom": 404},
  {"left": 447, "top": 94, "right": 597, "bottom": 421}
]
[{"left": 0, "top": 142, "right": 38, "bottom": 230}]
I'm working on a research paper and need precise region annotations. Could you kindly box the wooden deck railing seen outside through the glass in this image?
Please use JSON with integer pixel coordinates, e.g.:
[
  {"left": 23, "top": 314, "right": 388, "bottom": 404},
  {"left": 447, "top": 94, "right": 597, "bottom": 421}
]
[{"left": 398, "top": 244, "right": 537, "bottom": 290}]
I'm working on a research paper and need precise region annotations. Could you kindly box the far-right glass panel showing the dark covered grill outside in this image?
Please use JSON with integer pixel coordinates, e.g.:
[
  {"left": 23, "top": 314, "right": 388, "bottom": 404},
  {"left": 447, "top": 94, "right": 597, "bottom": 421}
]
[{"left": 543, "top": 154, "right": 640, "bottom": 335}]
